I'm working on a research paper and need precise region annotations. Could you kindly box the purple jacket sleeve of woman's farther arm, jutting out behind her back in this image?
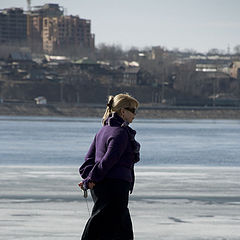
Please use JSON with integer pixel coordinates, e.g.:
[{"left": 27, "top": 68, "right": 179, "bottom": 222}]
[{"left": 79, "top": 136, "right": 96, "bottom": 179}]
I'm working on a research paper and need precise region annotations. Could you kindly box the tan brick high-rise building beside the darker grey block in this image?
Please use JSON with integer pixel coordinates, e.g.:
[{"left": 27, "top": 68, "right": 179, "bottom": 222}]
[{"left": 28, "top": 4, "right": 94, "bottom": 54}]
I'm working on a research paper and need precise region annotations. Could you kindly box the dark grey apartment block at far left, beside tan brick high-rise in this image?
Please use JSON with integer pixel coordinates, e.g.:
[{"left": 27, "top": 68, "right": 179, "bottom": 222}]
[{"left": 0, "top": 8, "right": 27, "bottom": 44}]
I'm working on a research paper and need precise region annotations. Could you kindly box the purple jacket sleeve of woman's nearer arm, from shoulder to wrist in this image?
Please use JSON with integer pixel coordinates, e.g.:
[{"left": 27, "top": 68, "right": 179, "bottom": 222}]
[{"left": 86, "top": 129, "right": 128, "bottom": 183}]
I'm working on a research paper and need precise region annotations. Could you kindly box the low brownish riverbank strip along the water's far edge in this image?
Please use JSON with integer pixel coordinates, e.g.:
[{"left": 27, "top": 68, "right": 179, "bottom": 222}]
[{"left": 0, "top": 103, "right": 240, "bottom": 119}]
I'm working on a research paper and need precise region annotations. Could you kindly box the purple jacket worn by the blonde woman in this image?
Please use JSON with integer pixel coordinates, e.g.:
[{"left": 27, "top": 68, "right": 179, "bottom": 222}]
[{"left": 79, "top": 113, "right": 140, "bottom": 190}]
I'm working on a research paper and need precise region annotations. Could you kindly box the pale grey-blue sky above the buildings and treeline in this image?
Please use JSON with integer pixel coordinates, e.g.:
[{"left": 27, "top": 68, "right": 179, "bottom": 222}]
[{"left": 0, "top": 0, "right": 240, "bottom": 53}]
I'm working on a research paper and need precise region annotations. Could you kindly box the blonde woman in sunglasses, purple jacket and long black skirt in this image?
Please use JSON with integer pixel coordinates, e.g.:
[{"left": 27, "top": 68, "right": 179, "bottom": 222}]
[{"left": 79, "top": 94, "right": 140, "bottom": 240}]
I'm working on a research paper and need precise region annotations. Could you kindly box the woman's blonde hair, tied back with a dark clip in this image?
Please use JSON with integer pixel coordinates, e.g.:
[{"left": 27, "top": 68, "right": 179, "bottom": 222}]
[{"left": 102, "top": 93, "right": 139, "bottom": 124}]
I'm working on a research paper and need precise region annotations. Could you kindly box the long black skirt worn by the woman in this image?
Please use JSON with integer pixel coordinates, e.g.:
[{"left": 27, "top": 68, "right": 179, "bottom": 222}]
[{"left": 82, "top": 179, "right": 133, "bottom": 240}]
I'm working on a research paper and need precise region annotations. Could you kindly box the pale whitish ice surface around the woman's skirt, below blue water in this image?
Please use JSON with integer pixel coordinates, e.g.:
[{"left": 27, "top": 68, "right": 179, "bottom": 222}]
[{"left": 0, "top": 166, "right": 240, "bottom": 240}]
